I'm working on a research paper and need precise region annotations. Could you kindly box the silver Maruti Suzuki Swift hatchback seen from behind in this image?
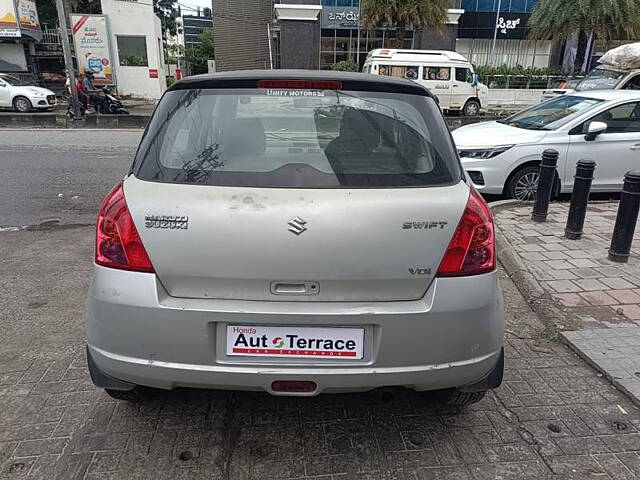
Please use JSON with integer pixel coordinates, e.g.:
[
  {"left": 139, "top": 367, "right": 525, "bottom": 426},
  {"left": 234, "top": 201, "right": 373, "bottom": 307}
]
[{"left": 86, "top": 70, "right": 504, "bottom": 405}]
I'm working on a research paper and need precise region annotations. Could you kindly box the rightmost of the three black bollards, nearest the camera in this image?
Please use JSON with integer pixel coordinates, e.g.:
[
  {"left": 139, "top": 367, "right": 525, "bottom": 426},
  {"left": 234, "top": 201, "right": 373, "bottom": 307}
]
[{"left": 609, "top": 171, "right": 640, "bottom": 263}]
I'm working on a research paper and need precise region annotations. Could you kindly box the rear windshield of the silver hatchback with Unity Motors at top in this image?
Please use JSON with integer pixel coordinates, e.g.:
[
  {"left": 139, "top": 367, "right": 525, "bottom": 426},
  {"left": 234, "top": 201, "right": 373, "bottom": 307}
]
[{"left": 133, "top": 88, "right": 461, "bottom": 188}]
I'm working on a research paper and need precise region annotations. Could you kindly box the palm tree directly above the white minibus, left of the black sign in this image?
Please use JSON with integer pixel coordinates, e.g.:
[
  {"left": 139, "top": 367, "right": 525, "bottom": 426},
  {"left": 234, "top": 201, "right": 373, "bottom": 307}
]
[{"left": 361, "top": 0, "right": 449, "bottom": 48}]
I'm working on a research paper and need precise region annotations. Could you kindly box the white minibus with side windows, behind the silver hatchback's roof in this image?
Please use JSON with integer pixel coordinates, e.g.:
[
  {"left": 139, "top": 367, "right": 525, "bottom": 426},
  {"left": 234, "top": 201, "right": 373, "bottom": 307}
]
[{"left": 363, "top": 49, "right": 489, "bottom": 116}]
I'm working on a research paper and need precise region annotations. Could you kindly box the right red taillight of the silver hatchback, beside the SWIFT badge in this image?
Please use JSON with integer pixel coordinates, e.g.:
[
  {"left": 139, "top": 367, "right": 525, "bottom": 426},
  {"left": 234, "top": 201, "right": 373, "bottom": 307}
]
[{"left": 438, "top": 188, "right": 496, "bottom": 277}]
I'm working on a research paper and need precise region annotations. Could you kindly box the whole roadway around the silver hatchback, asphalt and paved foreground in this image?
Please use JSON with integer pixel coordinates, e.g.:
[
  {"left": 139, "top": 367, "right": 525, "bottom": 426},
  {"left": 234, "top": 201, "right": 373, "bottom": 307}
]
[{"left": 0, "top": 130, "right": 640, "bottom": 480}]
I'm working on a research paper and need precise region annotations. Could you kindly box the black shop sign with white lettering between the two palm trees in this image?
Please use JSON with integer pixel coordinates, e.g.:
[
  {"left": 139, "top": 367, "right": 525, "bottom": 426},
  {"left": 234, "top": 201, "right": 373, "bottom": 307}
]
[{"left": 458, "top": 12, "right": 529, "bottom": 40}]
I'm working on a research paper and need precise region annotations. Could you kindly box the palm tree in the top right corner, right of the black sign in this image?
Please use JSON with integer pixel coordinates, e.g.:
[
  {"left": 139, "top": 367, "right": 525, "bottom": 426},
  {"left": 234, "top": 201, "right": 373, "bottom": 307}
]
[{"left": 529, "top": 0, "right": 640, "bottom": 70}]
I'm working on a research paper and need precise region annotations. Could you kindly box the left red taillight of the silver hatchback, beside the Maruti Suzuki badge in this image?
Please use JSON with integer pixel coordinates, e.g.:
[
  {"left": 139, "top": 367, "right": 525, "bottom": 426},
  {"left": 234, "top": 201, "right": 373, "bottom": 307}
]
[{"left": 95, "top": 182, "right": 154, "bottom": 273}]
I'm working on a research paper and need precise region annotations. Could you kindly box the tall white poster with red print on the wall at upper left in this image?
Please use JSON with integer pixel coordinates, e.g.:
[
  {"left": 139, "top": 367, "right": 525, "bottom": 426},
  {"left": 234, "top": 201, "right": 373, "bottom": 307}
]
[{"left": 70, "top": 14, "right": 114, "bottom": 85}]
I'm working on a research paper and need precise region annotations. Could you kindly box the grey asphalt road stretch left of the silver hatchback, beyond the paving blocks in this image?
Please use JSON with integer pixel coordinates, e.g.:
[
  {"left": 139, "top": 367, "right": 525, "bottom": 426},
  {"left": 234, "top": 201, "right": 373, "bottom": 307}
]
[{"left": 0, "top": 129, "right": 142, "bottom": 229}]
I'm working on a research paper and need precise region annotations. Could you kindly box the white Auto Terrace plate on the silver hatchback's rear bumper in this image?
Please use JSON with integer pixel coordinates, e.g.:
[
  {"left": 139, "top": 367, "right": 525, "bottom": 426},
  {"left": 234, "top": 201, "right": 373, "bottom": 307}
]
[{"left": 227, "top": 325, "right": 364, "bottom": 360}]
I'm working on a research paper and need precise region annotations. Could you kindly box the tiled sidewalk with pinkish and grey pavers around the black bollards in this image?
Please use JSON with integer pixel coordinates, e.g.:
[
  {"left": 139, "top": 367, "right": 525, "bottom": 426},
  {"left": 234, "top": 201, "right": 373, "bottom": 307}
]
[{"left": 496, "top": 202, "right": 640, "bottom": 404}]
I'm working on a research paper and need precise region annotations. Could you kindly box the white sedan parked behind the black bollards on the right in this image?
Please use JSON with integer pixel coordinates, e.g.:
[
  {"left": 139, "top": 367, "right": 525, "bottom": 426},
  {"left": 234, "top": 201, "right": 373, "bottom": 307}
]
[{"left": 453, "top": 90, "right": 640, "bottom": 200}]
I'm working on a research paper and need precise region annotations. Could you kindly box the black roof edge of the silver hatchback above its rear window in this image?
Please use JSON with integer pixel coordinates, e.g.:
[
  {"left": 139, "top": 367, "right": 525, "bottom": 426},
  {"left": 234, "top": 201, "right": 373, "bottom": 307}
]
[{"left": 168, "top": 70, "right": 433, "bottom": 98}]
